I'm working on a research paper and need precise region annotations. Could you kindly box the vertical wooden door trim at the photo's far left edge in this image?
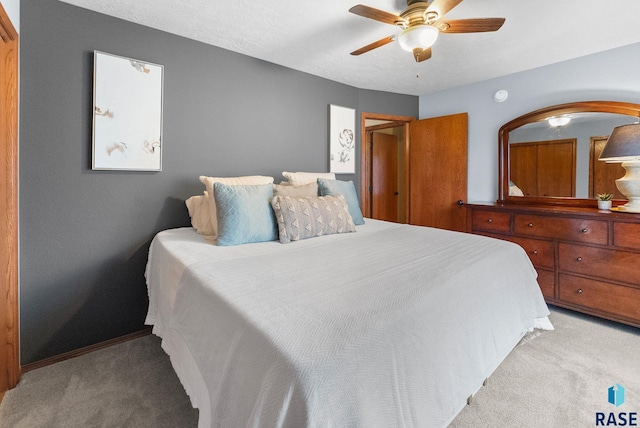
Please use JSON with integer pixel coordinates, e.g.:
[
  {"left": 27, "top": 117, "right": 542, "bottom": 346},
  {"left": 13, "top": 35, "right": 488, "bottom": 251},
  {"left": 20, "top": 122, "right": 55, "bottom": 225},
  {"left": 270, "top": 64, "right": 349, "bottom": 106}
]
[{"left": 0, "top": 4, "right": 20, "bottom": 395}]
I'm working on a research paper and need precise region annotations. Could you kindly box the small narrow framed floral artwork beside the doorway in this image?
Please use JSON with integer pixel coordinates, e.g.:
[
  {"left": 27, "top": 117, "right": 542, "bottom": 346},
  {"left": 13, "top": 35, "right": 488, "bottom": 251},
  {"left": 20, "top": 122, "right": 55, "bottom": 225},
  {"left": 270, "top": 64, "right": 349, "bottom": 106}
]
[{"left": 329, "top": 104, "right": 356, "bottom": 174}]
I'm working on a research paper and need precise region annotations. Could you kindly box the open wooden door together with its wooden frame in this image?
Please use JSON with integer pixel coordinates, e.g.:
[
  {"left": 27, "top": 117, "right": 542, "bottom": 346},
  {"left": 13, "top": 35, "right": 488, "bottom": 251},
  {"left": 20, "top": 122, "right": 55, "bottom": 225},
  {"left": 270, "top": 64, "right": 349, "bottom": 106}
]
[{"left": 360, "top": 113, "right": 468, "bottom": 231}]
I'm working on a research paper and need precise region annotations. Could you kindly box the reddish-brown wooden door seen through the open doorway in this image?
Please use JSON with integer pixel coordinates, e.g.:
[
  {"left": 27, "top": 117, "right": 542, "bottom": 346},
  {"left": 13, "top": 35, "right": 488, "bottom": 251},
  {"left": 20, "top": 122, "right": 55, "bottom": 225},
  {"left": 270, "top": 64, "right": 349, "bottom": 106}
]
[{"left": 369, "top": 131, "right": 399, "bottom": 222}]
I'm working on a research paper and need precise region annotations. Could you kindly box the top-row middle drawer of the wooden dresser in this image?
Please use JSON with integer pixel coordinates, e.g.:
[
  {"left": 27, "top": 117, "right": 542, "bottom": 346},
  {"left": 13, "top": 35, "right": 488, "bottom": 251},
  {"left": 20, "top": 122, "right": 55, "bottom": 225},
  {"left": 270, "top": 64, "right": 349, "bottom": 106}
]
[{"left": 514, "top": 214, "right": 609, "bottom": 245}]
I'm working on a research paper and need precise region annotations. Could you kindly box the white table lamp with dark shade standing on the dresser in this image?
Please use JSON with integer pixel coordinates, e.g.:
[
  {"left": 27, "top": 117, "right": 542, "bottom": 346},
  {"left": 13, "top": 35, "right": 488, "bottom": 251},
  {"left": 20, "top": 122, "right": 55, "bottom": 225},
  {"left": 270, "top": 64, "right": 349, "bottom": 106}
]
[{"left": 599, "top": 123, "right": 640, "bottom": 213}]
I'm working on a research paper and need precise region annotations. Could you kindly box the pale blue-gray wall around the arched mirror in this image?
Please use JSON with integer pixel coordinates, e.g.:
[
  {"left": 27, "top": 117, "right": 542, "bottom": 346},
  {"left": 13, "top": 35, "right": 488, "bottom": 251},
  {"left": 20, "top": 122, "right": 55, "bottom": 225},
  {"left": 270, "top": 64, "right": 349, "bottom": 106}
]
[{"left": 420, "top": 43, "right": 640, "bottom": 201}]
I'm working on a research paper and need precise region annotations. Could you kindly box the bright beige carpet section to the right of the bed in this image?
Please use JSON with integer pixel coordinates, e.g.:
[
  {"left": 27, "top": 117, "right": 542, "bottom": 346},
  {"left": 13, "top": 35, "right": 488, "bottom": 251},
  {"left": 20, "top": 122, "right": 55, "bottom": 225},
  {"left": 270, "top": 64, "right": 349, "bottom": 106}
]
[{"left": 451, "top": 302, "right": 640, "bottom": 428}]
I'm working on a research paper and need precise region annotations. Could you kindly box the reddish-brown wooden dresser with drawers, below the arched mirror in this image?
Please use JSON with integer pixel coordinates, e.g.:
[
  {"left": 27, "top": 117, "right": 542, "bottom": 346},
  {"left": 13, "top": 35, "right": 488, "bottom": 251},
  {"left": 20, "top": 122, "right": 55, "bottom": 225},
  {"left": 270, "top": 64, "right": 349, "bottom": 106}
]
[{"left": 467, "top": 204, "right": 640, "bottom": 327}]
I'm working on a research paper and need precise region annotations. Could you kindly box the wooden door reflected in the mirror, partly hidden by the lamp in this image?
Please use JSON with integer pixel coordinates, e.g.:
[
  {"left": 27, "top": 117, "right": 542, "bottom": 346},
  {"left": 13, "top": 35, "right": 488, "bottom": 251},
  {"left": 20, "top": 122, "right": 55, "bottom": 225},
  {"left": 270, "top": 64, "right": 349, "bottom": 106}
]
[{"left": 589, "top": 136, "right": 626, "bottom": 199}]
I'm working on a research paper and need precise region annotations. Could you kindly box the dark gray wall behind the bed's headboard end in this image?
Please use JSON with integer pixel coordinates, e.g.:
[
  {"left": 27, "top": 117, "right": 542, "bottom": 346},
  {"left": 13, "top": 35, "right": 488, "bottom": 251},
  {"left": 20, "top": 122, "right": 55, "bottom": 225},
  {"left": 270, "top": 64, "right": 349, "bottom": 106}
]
[{"left": 20, "top": 0, "right": 418, "bottom": 364}]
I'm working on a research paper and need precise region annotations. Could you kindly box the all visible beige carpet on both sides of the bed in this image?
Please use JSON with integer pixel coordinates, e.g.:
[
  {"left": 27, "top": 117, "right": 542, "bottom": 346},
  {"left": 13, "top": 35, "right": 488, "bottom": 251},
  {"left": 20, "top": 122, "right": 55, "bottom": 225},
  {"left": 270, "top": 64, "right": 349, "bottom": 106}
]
[{"left": 0, "top": 308, "right": 640, "bottom": 428}]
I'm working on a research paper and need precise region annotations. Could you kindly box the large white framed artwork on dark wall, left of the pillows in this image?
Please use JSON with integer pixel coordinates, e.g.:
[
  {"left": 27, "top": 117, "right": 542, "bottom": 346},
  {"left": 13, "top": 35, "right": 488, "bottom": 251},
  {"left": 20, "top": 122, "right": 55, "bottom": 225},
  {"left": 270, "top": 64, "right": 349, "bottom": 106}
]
[{"left": 91, "top": 51, "right": 164, "bottom": 171}]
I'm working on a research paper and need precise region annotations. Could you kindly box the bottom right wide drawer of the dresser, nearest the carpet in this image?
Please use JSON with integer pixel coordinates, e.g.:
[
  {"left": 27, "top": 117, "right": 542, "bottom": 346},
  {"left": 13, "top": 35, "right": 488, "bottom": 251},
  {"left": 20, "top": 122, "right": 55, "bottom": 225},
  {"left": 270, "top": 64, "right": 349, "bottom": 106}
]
[{"left": 558, "top": 274, "right": 640, "bottom": 320}]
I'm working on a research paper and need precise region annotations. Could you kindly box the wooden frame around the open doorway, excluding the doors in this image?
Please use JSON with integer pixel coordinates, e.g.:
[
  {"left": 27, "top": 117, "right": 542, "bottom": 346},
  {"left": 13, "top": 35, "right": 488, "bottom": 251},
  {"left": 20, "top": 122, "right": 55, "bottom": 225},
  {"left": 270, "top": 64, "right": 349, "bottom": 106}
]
[{"left": 360, "top": 112, "right": 415, "bottom": 217}]
